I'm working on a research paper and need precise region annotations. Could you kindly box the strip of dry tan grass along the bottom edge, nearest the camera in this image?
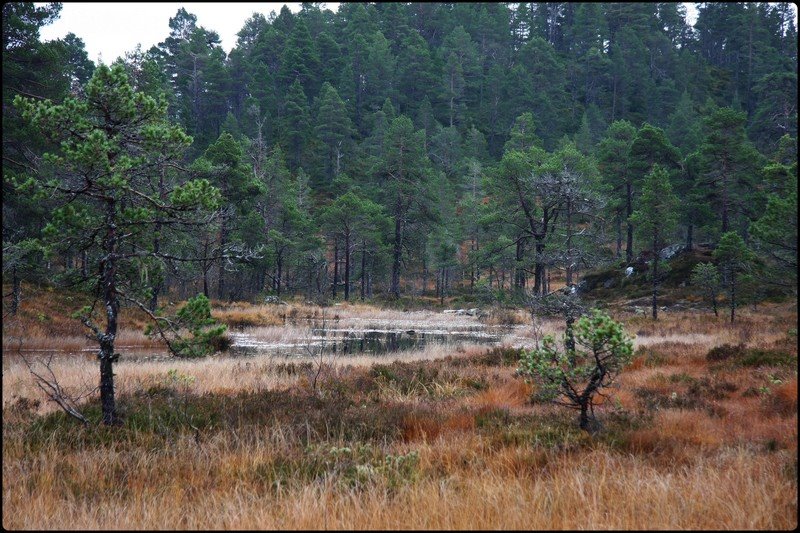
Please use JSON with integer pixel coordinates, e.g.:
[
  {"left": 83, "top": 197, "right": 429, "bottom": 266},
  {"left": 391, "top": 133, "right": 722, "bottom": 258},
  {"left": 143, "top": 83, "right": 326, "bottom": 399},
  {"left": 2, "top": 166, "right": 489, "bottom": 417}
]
[{"left": 3, "top": 432, "right": 797, "bottom": 529}]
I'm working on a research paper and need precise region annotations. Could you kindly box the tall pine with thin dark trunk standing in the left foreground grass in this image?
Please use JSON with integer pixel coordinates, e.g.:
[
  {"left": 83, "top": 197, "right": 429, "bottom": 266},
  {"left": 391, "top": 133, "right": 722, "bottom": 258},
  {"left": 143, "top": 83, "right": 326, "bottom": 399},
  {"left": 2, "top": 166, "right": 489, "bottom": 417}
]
[{"left": 15, "top": 65, "right": 219, "bottom": 424}]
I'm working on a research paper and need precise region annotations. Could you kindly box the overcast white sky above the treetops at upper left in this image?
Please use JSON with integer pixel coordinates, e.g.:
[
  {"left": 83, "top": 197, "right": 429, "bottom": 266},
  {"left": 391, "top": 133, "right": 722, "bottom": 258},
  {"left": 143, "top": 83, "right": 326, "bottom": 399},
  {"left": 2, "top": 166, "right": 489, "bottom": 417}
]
[{"left": 36, "top": 2, "right": 339, "bottom": 64}]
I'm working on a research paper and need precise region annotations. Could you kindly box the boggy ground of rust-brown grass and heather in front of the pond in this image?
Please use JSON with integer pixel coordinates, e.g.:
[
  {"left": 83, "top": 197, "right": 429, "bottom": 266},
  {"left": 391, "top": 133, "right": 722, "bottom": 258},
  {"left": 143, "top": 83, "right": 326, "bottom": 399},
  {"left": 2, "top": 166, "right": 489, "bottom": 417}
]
[{"left": 3, "top": 296, "right": 798, "bottom": 529}]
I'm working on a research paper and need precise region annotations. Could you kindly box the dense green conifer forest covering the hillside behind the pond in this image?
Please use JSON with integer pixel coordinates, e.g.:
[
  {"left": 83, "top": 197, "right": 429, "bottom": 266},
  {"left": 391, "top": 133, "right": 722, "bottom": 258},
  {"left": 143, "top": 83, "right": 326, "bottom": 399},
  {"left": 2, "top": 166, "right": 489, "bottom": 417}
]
[{"left": 3, "top": 3, "right": 797, "bottom": 310}]
